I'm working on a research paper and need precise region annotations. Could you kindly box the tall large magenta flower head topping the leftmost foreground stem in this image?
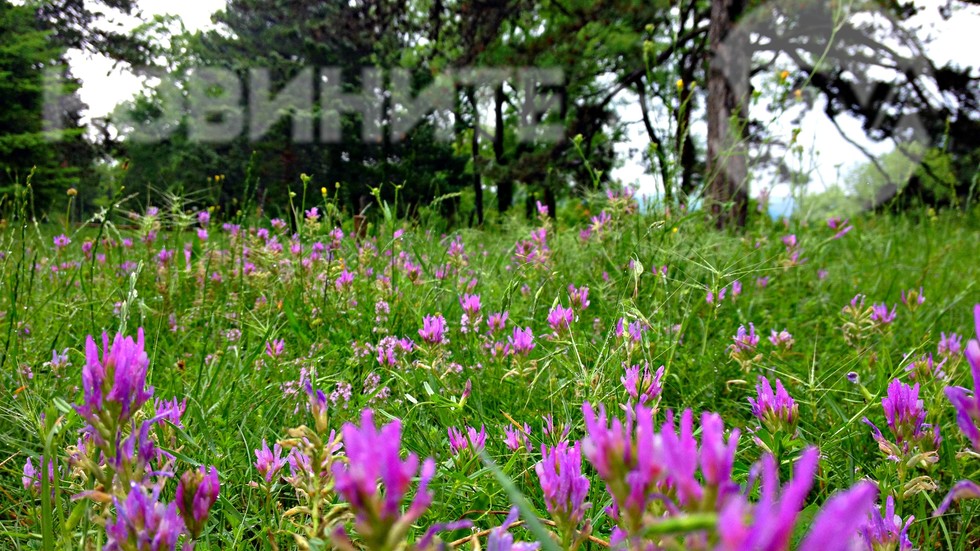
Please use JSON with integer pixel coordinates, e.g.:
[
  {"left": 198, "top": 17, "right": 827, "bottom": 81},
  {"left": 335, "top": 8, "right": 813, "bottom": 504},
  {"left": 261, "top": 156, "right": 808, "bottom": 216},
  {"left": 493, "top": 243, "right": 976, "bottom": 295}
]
[{"left": 75, "top": 328, "right": 153, "bottom": 438}]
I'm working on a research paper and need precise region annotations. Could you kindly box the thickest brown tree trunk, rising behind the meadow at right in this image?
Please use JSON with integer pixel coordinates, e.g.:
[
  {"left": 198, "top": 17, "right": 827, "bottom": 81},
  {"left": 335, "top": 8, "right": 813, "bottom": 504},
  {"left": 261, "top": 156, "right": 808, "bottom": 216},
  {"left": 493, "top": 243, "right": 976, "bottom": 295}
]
[{"left": 708, "top": 0, "right": 749, "bottom": 228}]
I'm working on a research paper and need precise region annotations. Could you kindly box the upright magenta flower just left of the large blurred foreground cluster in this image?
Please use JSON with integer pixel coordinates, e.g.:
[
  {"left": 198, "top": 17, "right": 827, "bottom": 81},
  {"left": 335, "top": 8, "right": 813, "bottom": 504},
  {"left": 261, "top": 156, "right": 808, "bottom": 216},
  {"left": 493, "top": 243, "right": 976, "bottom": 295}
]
[{"left": 534, "top": 442, "right": 591, "bottom": 528}]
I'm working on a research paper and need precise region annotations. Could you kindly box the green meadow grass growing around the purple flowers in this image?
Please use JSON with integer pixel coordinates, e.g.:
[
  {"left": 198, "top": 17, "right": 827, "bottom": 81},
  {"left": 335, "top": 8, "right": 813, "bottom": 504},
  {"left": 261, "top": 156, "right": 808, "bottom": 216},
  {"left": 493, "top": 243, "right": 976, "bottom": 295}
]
[{"left": 0, "top": 189, "right": 980, "bottom": 549}]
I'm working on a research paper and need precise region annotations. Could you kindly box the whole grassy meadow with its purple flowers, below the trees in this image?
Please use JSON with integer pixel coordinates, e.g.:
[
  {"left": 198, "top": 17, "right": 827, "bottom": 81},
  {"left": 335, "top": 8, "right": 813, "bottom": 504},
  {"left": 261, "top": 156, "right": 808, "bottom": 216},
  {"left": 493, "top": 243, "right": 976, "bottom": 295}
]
[{"left": 0, "top": 190, "right": 980, "bottom": 551}]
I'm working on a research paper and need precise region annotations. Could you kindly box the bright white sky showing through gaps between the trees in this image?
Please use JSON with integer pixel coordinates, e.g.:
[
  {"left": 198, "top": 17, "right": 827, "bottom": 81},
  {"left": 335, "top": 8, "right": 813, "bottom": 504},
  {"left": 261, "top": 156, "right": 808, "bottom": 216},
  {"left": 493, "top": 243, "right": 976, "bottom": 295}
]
[{"left": 59, "top": 0, "right": 980, "bottom": 203}]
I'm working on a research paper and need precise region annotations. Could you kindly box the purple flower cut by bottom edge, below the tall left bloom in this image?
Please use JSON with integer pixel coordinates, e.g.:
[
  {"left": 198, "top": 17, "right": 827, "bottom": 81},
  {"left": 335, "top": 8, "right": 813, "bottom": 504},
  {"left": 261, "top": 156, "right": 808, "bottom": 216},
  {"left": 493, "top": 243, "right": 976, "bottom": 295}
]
[{"left": 105, "top": 484, "right": 184, "bottom": 551}]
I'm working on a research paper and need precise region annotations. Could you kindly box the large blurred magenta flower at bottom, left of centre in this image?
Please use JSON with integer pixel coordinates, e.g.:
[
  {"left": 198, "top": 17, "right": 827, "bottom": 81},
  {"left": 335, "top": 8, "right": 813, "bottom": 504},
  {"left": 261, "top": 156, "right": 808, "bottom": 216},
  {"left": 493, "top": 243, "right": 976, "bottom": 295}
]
[{"left": 333, "top": 409, "right": 436, "bottom": 549}]
